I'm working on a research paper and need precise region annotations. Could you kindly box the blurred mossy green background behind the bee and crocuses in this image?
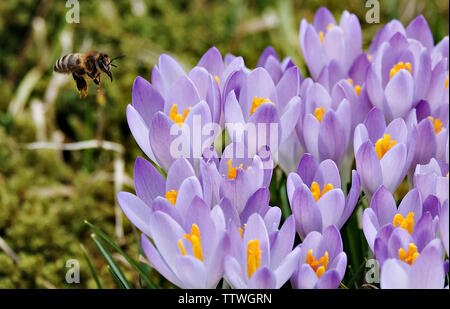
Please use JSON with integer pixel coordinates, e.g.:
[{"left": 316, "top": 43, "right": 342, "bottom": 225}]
[{"left": 0, "top": 0, "right": 449, "bottom": 288}]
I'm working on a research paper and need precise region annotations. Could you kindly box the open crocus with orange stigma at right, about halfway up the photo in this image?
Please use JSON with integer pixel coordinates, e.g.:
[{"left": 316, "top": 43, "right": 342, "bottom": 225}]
[{"left": 353, "top": 108, "right": 415, "bottom": 197}]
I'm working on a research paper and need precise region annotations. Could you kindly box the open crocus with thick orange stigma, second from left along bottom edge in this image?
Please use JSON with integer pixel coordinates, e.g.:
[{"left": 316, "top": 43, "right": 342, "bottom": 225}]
[{"left": 224, "top": 214, "right": 300, "bottom": 289}]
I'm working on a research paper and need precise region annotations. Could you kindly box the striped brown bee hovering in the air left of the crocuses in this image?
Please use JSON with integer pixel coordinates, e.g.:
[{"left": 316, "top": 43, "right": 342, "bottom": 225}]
[{"left": 53, "top": 51, "right": 124, "bottom": 98}]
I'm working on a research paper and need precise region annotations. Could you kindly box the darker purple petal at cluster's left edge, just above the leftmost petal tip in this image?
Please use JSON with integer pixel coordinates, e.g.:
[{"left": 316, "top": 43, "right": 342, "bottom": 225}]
[{"left": 134, "top": 157, "right": 166, "bottom": 205}]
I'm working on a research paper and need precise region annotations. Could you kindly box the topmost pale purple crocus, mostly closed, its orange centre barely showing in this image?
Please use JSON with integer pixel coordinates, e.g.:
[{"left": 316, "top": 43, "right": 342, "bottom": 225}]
[{"left": 300, "top": 7, "right": 362, "bottom": 87}]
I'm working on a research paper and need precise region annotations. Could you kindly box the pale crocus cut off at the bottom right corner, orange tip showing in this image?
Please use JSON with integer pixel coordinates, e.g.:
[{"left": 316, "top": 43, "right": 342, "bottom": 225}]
[{"left": 380, "top": 236, "right": 445, "bottom": 289}]
